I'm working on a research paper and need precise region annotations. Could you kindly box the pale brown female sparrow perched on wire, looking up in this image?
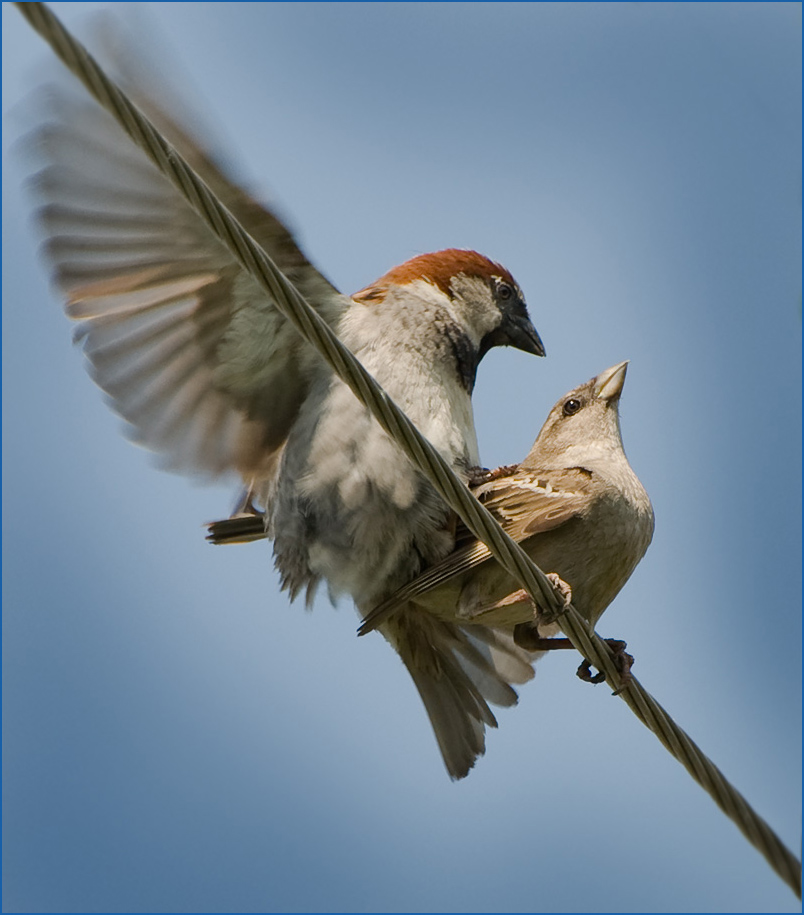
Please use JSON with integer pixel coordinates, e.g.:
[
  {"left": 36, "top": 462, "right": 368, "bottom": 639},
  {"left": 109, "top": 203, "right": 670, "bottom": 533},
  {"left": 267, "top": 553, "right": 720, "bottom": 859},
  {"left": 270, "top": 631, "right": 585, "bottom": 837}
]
[{"left": 359, "top": 362, "right": 653, "bottom": 777}]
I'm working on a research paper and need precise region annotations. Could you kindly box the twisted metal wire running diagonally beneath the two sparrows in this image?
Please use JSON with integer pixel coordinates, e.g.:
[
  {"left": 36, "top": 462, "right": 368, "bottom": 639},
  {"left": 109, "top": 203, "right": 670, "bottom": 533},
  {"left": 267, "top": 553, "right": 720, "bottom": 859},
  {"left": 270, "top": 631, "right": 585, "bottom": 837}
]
[{"left": 15, "top": 3, "right": 801, "bottom": 898}]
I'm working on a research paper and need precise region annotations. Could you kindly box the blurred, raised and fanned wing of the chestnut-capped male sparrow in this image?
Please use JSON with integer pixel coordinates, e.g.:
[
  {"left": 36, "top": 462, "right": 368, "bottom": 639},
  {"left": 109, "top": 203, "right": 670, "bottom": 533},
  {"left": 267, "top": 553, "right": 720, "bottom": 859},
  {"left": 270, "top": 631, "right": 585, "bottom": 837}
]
[{"left": 28, "top": 62, "right": 348, "bottom": 477}]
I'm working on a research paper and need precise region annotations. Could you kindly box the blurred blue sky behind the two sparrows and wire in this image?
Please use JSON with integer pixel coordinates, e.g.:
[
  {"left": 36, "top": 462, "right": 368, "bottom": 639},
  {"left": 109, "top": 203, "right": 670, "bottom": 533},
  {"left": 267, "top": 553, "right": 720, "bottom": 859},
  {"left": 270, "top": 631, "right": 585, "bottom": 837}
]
[{"left": 2, "top": 3, "right": 801, "bottom": 912}]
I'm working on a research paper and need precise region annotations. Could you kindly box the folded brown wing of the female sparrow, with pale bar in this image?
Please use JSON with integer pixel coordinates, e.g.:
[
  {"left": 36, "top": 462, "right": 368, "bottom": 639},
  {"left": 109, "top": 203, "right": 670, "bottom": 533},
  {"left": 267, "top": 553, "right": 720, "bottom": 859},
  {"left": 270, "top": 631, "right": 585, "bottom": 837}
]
[{"left": 358, "top": 467, "right": 589, "bottom": 635}]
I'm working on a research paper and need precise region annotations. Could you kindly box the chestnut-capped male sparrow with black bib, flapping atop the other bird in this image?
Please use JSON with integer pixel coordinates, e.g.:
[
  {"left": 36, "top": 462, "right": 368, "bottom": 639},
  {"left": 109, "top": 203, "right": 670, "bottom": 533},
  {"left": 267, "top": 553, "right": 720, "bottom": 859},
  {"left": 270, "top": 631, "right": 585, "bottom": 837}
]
[{"left": 23, "top": 48, "right": 544, "bottom": 774}]
